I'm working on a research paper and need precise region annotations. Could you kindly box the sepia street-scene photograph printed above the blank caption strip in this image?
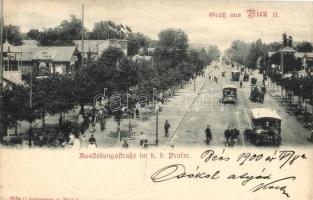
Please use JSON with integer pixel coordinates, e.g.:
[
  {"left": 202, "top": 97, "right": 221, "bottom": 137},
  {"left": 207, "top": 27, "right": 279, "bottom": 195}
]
[{"left": 0, "top": 0, "right": 313, "bottom": 148}]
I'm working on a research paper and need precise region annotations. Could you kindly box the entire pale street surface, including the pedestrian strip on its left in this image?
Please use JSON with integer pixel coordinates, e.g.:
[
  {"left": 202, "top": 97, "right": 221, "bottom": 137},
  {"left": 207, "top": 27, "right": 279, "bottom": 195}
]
[{"left": 79, "top": 59, "right": 310, "bottom": 147}]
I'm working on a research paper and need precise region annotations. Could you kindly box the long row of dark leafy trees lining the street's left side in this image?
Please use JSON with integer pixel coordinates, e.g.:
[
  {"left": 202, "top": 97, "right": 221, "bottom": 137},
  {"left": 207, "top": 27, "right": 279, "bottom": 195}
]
[{"left": 1, "top": 29, "right": 220, "bottom": 145}]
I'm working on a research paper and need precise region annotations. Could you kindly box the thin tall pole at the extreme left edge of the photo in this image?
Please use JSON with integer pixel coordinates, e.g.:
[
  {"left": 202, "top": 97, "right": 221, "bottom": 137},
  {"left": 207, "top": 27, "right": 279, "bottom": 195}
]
[{"left": 0, "top": 0, "right": 4, "bottom": 144}]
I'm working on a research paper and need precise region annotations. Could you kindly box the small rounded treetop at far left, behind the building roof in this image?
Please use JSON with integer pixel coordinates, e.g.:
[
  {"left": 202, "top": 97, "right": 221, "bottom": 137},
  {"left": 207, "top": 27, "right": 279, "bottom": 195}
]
[{"left": 3, "top": 25, "right": 23, "bottom": 45}]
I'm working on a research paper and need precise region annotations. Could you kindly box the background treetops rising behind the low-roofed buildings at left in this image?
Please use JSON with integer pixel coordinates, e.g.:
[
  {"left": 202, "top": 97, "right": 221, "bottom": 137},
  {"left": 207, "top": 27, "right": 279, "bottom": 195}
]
[{"left": 3, "top": 15, "right": 153, "bottom": 56}]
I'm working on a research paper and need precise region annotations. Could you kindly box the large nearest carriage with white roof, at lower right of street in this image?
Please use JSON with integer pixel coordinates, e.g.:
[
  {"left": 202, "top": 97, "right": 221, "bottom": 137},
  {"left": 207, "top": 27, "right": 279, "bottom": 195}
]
[{"left": 245, "top": 108, "right": 281, "bottom": 146}]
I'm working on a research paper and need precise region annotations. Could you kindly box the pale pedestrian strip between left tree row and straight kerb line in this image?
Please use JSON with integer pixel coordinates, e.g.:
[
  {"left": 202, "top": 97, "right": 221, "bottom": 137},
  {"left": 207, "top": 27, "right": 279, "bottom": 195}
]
[{"left": 81, "top": 65, "right": 209, "bottom": 148}]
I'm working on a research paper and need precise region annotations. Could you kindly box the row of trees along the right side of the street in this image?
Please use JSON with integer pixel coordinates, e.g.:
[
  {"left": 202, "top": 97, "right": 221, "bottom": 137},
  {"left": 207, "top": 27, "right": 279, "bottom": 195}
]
[{"left": 225, "top": 33, "right": 313, "bottom": 116}]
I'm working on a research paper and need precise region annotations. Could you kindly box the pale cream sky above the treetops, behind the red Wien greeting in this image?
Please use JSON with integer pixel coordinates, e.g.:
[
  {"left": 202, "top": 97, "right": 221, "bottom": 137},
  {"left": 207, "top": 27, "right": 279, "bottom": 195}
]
[{"left": 4, "top": 0, "right": 313, "bottom": 50}]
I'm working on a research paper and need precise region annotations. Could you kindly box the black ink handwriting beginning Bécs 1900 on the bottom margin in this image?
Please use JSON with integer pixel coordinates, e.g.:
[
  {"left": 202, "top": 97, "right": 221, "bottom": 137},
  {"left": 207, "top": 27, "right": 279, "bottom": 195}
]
[{"left": 151, "top": 149, "right": 307, "bottom": 198}]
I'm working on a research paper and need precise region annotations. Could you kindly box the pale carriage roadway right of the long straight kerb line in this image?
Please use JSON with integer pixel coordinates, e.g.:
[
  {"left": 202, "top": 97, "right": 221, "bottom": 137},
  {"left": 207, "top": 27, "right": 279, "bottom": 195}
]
[{"left": 162, "top": 63, "right": 310, "bottom": 147}]
